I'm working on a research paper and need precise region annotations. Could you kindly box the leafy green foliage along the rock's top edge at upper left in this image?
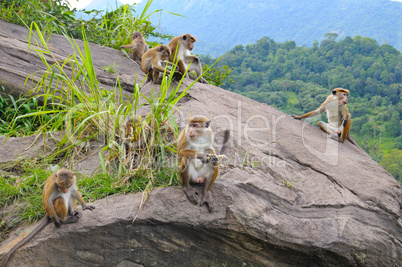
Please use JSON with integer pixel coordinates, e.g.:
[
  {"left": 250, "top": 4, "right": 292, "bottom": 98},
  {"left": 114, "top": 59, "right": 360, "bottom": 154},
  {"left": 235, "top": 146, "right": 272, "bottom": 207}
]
[{"left": 0, "top": 0, "right": 171, "bottom": 49}]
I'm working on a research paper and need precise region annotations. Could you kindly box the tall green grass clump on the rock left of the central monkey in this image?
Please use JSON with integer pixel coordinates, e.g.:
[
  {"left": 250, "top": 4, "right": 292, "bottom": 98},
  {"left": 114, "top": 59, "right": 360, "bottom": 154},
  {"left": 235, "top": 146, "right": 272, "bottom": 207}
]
[{"left": 0, "top": 17, "right": 196, "bottom": 234}]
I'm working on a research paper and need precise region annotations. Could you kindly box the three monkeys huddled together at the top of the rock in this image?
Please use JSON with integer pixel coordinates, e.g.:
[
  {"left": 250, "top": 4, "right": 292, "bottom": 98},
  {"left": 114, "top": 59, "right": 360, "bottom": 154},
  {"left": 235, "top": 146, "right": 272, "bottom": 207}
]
[{"left": 120, "top": 32, "right": 208, "bottom": 83}]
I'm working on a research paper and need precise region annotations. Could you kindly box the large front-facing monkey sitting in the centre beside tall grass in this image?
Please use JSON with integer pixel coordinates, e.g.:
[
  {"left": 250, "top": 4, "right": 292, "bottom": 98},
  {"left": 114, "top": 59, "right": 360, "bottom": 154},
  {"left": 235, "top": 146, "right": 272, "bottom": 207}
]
[{"left": 177, "top": 115, "right": 229, "bottom": 212}]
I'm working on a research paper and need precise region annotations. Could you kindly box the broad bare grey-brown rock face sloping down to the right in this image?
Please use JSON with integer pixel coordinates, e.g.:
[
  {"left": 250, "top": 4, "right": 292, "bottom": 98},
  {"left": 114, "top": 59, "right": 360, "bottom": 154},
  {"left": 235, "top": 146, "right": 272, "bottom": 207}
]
[{"left": 0, "top": 21, "right": 402, "bottom": 266}]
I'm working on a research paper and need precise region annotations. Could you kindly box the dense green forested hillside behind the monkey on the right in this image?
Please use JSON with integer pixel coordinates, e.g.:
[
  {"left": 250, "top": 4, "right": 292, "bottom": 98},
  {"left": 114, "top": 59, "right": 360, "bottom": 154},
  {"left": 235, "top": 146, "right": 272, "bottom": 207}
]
[{"left": 202, "top": 33, "right": 402, "bottom": 182}]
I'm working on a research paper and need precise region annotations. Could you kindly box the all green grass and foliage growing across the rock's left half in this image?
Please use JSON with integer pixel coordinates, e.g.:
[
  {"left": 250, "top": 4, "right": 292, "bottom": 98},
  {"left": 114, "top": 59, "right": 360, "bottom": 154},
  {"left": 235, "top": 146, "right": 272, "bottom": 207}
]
[{"left": 0, "top": 0, "right": 217, "bottom": 238}]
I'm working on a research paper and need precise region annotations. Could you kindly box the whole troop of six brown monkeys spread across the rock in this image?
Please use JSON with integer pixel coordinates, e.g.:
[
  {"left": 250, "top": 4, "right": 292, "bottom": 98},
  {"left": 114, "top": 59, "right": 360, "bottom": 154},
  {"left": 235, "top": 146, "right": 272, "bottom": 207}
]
[{"left": 1, "top": 32, "right": 358, "bottom": 267}]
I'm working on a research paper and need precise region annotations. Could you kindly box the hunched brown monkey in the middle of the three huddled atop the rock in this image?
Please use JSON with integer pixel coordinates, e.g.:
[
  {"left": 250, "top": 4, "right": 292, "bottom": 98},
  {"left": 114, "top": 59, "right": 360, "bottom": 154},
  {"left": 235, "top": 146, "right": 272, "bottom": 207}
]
[{"left": 141, "top": 45, "right": 181, "bottom": 83}]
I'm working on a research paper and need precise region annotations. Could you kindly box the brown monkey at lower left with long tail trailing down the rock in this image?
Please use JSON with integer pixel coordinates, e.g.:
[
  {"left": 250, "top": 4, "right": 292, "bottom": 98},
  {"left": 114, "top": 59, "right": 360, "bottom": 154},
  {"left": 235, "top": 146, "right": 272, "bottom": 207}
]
[{"left": 1, "top": 169, "right": 95, "bottom": 267}]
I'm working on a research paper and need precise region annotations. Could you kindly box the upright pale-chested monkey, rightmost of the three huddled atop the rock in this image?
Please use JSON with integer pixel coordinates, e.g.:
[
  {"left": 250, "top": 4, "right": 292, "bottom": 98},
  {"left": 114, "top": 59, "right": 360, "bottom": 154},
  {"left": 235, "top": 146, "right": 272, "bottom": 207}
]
[{"left": 169, "top": 33, "right": 208, "bottom": 83}]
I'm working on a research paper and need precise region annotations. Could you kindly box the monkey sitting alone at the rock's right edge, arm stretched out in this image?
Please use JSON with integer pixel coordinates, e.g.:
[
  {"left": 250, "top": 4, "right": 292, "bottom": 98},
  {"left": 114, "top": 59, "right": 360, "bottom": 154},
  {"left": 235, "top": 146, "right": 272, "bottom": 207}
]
[{"left": 292, "top": 88, "right": 358, "bottom": 146}]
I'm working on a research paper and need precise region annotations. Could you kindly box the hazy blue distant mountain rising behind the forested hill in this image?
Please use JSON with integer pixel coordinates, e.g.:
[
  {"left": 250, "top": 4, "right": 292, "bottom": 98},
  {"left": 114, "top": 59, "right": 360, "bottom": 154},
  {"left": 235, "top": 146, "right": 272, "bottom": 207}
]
[{"left": 138, "top": 0, "right": 402, "bottom": 56}]
